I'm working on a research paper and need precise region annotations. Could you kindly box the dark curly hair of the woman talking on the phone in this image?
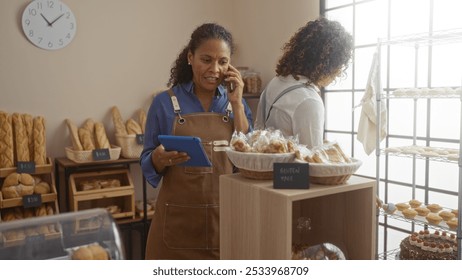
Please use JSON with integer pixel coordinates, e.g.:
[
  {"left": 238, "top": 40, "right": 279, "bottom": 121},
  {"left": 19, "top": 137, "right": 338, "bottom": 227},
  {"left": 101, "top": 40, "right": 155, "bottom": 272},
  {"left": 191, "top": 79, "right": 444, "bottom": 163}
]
[{"left": 167, "top": 23, "right": 234, "bottom": 86}]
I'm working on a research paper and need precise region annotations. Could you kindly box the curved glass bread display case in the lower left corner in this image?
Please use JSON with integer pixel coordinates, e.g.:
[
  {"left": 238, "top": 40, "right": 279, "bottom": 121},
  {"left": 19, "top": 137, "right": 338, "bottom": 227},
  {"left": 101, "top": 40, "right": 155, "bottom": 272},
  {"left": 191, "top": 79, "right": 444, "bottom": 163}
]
[{"left": 0, "top": 209, "right": 125, "bottom": 260}]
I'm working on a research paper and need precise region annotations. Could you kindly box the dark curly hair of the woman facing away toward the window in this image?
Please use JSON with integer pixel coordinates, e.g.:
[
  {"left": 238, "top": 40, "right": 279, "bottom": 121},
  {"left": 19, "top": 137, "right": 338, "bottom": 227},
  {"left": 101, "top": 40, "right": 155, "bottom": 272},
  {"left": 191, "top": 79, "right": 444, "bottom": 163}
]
[{"left": 276, "top": 17, "right": 353, "bottom": 85}]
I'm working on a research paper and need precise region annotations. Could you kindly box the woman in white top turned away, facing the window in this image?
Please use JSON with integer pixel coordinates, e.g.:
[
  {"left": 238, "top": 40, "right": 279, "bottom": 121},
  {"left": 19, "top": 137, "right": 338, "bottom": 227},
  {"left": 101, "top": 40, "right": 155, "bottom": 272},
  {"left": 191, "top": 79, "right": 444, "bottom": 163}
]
[{"left": 255, "top": 18, "right": 353, "bottom": 148}]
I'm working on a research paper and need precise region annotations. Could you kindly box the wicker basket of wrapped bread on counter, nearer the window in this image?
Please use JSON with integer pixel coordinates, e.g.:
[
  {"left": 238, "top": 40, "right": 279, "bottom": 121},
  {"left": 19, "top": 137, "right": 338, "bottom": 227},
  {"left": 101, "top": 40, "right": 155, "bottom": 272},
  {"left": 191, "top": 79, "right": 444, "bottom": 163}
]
[{"left": 295, "top": 142, "right": 362, "bottom": 185}]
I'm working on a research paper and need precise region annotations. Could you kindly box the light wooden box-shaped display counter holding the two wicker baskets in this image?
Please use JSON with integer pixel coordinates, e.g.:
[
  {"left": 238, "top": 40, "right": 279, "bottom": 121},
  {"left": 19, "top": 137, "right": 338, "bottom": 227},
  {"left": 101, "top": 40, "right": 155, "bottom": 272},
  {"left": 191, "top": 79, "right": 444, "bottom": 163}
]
[{"left": 220, "top": 174, "right": 376, "bottom": 260}]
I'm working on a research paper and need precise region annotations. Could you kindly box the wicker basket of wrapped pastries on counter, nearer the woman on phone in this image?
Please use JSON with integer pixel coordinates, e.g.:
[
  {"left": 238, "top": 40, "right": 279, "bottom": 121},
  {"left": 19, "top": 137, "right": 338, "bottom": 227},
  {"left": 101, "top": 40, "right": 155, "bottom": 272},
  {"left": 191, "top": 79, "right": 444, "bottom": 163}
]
[{"left": 226, "top": 130, "right": 296, "bottom": 180}]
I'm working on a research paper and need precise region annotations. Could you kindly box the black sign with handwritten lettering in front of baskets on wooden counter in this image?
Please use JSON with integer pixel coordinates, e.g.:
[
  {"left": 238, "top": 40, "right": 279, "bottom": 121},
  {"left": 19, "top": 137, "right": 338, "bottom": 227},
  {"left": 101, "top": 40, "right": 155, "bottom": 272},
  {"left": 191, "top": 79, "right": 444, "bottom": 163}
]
[{"left": 273, "top": 163, "right": 310, "bottom": 189}]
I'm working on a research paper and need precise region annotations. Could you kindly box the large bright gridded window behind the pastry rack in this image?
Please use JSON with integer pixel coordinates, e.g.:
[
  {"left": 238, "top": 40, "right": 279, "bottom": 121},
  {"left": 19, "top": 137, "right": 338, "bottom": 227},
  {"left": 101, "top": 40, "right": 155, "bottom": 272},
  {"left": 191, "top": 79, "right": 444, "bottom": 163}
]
[{"left": 320, "top": 0, "right": 462, "bottom": 258}]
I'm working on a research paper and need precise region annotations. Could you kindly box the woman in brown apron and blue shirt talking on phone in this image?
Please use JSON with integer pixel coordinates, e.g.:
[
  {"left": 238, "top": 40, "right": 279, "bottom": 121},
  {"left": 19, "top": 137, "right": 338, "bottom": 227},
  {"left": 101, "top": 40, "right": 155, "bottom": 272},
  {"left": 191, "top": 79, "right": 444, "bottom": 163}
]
[{"left": 140, "top": 24, "right": 252, "bottom": 259}]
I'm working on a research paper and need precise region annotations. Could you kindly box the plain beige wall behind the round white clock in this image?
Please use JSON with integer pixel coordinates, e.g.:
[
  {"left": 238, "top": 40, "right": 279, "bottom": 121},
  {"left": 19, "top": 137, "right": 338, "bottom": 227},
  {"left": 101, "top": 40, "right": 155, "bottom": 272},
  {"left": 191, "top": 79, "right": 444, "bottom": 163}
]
[{"left": 0, "top": 0, "right": 319, "bottom": 195}]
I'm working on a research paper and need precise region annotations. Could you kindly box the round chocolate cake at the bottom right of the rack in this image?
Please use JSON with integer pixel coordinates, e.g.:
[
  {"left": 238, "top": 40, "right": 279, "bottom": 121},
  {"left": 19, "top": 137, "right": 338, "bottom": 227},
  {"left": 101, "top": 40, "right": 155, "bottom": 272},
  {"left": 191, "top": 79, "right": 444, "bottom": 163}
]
[{"left": 399, "top": 230, "right": 457, "bottom": 260}]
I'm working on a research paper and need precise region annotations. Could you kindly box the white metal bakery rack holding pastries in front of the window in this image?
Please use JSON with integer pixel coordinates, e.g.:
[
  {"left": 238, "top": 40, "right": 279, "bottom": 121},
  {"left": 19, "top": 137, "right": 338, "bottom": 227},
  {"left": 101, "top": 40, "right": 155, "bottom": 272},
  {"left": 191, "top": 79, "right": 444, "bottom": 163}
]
[{"left": 376, "top": 28, "right": 462, "bottom": 260}]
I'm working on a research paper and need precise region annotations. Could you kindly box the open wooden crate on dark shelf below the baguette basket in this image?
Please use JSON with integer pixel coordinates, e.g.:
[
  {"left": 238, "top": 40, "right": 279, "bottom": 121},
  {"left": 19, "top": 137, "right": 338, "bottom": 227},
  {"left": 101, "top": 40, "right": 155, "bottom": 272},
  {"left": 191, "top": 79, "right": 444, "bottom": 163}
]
[{"left": 69, "top": 169, "right": 135, "bottom": 219}]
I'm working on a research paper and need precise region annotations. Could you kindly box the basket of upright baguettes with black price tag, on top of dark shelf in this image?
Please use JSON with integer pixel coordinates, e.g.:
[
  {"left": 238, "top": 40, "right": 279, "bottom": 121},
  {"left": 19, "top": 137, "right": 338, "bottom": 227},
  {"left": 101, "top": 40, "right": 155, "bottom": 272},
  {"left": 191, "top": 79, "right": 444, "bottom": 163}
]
[{"left": 65, "top": 118, "right": 121, "bottom": 163}]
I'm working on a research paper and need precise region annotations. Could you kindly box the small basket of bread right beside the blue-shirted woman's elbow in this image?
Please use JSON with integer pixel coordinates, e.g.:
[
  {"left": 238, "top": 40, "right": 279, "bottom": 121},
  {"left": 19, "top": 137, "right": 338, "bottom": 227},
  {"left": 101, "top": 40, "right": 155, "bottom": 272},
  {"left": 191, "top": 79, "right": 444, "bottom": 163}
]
[{"left": 111, "top": 106, "right": 146, "bottom": 158}]
